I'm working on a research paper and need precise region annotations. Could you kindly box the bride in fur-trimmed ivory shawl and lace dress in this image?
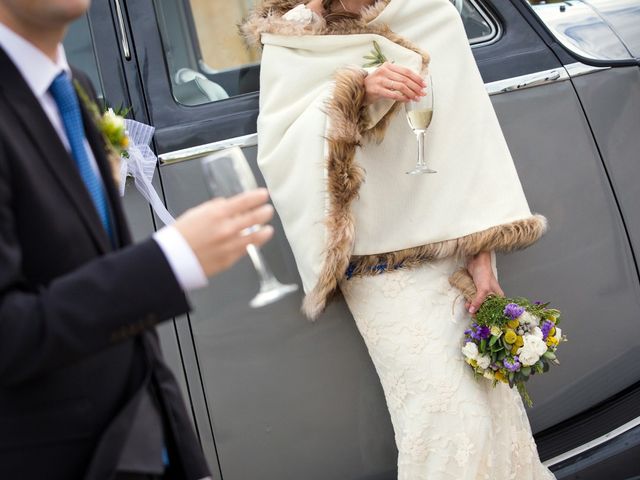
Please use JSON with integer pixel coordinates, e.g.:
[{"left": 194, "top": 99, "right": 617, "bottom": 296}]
[{"left": 242, "top": 0, "right": 554, "bottom": 480}]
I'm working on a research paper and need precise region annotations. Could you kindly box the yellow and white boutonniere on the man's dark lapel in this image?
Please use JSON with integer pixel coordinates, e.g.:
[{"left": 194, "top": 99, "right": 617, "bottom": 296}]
[{"left": 74, "top": 80, "right": 130, "bottom": 184}]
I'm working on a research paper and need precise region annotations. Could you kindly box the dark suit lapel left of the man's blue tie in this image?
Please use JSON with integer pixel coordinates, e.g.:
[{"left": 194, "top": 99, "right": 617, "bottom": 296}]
[{"left": 0, "top": 48, "right": 111, "bottom": 253}]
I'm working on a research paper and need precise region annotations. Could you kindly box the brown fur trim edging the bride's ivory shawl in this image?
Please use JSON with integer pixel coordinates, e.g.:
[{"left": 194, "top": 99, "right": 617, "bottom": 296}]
[{"left": 241, "top": 0, "right": 547, "bottom": 319}]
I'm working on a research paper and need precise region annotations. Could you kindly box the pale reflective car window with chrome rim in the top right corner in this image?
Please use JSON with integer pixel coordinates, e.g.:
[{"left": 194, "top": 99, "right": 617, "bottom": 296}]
[{"left": 528, "top": 0, "right": 640, "bottom": 60}]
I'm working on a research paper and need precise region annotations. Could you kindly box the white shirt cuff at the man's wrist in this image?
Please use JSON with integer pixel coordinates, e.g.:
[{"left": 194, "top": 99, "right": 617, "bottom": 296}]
[{"left": 153, "top": 225, "right": 209, "bottom": 292}]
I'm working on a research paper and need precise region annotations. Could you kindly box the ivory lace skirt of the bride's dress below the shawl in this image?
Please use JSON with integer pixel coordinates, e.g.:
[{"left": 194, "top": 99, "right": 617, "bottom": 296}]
[{"left": 340, "top": 259, "right": 554, "bottom": 480}]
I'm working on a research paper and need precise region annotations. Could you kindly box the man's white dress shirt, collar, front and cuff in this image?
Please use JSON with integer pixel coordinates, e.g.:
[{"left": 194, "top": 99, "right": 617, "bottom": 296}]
[{"left": 0, "top": 23, "right": 208, "bottom": 291}]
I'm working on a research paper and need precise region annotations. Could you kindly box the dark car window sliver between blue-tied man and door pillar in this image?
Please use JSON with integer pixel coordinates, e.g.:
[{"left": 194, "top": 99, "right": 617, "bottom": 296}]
[{"left": 63, "top": 15, "right": 104, "bottom": 100}]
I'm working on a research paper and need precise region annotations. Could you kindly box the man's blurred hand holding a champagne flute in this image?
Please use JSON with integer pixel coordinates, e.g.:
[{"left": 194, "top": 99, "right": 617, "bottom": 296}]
[{"left": 174, "top": 188, "right": 273, "bottom": 277}]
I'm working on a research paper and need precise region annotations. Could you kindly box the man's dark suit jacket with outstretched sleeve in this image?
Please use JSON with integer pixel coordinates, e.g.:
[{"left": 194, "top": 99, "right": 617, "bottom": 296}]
[{"left": 0, "top": 48, "right": 208, "bottom": 480}]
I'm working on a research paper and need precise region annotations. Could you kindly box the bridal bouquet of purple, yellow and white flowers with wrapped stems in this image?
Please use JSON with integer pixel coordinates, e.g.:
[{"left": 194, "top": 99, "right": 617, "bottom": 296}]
[{"left": 452, "top": 266, "right": 566, "bottom": 406}]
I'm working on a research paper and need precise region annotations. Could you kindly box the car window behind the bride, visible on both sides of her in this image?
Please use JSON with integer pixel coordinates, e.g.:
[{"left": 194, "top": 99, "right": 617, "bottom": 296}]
[{"left": 154, "top": 0, "right": 499, "bottom": 106}]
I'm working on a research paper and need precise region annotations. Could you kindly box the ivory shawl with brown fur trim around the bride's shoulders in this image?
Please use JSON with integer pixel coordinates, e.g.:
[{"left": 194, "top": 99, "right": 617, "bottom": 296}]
[{"left": 242, "top": 0, "right": 546, "bottom": 318}]
